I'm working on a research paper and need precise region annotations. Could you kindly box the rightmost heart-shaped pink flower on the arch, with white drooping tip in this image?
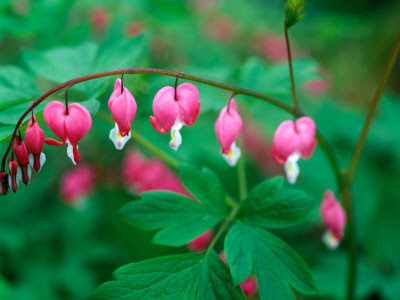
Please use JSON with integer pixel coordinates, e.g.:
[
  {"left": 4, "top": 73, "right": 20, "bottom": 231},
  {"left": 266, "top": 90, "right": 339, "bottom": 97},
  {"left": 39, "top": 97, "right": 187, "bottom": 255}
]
[{"left": 271, "top": 117, "right": 317, "bottom": 183}]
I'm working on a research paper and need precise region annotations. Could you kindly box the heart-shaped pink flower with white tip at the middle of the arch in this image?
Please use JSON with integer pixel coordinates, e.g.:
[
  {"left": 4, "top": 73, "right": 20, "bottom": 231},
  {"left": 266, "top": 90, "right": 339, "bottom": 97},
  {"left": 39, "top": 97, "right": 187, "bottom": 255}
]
[{"left": 150, "top": 83, "right": 200, "bottom": 150}]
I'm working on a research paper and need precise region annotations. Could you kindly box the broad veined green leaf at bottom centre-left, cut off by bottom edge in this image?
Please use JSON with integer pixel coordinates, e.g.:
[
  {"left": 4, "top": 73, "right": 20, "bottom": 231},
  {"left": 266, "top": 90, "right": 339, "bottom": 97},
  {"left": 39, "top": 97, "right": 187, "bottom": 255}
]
[{"left": 91, "top": 251, "right": 245, "bottom": 300}]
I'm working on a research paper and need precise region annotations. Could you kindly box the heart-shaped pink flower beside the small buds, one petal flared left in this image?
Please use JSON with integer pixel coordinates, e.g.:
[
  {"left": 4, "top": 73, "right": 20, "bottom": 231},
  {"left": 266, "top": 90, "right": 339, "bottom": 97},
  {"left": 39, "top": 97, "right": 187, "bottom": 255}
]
[{"left": 43, "top": 101, "right": 92, "bottom": 164}]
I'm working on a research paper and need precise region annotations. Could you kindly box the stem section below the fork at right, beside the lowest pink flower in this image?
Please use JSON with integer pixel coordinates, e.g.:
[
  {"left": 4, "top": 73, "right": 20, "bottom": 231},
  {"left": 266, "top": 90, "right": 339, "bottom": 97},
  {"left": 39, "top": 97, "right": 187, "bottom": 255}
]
[{"left": 341, "top": 185, "right": 357, "bottom": 300}]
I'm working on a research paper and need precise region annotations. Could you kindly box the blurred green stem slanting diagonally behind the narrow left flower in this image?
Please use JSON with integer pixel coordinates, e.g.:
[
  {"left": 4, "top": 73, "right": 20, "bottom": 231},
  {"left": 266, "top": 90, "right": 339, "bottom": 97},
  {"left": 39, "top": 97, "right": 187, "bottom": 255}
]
[{"left": 97, "top": 111, "right": 179, "bottom": 169}]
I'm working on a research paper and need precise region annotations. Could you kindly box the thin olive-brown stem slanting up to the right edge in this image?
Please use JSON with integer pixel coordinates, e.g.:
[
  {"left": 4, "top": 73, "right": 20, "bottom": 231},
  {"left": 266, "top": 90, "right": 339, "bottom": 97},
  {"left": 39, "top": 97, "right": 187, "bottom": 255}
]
[{"left": 346, "top": 34, "right": 400, "bottom": 183}]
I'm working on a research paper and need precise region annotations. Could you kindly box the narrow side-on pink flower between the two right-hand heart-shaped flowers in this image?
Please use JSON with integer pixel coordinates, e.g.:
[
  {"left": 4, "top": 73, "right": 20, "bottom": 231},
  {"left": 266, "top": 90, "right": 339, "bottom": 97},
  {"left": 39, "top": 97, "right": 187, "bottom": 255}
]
[{"left": 215, "top": 98, "right": 243, "bottom": 166}]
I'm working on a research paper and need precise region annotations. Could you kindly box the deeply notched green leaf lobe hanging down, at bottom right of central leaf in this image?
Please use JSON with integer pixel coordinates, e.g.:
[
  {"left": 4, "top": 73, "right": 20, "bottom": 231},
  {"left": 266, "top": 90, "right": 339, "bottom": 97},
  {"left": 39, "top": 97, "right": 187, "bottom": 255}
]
[{"left": 224, "top": 223, "right": 316, "bottom": 300}]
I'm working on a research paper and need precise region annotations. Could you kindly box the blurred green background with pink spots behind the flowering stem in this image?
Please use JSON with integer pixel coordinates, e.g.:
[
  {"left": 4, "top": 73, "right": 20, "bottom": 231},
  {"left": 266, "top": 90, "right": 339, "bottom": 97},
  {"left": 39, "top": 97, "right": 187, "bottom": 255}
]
[{"left": 0, "top": 0, "right": 400, "bottom": 300}]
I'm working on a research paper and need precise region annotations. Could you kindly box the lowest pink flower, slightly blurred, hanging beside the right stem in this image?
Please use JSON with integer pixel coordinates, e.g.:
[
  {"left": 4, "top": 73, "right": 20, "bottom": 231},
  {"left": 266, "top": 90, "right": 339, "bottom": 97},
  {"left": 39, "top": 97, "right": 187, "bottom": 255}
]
[{"left": 319, "top": 190, "right": 347, "bottom": 250}]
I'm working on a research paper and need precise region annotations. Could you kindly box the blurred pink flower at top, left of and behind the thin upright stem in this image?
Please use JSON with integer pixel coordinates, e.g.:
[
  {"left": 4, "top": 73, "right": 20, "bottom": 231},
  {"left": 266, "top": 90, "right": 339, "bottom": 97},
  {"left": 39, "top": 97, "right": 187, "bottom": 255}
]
[{"left": 253, "top": 33, "right": 301, "bottom": 63}]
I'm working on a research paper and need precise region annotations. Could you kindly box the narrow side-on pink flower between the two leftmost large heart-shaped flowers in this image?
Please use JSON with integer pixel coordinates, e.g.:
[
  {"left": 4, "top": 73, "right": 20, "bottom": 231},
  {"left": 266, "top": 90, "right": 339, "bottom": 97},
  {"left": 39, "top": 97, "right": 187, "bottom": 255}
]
[{"left": 108, "top": 78, "right": 137, "bottom": 150}]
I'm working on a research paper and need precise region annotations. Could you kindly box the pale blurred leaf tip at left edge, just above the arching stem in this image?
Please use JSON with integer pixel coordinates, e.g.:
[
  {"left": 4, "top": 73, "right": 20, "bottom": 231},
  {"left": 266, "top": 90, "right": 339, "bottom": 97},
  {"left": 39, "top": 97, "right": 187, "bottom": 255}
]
[{"left": 0, "top": 66, "right": 40, "bottom": 109}]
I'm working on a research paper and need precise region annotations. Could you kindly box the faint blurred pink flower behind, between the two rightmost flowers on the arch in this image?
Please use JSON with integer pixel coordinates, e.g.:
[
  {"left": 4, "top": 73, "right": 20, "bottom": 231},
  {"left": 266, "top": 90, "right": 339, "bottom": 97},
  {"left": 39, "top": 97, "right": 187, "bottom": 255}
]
[{"left": 242, "top": 119, "right": 281, "bottom": 175}]
